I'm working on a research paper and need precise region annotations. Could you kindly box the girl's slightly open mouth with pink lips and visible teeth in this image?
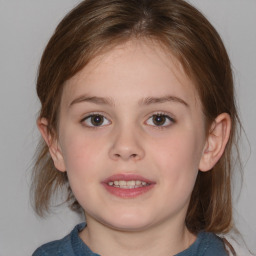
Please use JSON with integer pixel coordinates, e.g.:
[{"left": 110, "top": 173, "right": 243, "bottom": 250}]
[{"left": 102, "top": 174, "right": 156, "bottom": 198}]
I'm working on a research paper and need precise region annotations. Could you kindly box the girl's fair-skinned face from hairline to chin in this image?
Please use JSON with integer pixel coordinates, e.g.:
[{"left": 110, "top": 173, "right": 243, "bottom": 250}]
[{"left": 55, "top": 41, "right": 206, "bottom": 230}]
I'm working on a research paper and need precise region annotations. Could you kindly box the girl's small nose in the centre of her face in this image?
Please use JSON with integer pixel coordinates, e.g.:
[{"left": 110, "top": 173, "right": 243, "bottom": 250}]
[{"left": 109, "top": 127, "right": 145, "bottom": 161}]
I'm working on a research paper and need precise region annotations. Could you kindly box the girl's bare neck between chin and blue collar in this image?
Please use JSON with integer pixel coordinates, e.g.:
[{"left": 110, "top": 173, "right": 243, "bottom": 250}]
[{"left": 80, "top": 217, "right": 196, "bottom": 256}]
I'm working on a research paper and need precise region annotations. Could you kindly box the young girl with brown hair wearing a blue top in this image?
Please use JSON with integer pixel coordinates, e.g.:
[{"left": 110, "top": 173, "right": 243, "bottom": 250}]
[{"left": 33, "top": 0, "right": 238, "bottom": 256}]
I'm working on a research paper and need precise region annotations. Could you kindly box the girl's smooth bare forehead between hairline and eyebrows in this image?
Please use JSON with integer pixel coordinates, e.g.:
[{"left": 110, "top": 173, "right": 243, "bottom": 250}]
[{"left": 63, "top": 39, "right": 198, "bottom": 107}]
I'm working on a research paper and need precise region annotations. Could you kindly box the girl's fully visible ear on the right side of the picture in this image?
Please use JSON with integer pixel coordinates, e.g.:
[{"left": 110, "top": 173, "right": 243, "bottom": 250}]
[{"left": 199, "top": 113, "right": 231, "bottom": 172}]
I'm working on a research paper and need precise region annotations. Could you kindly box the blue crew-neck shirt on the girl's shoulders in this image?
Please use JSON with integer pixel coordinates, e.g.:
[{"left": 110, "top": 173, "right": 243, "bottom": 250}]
[{"left": 32, "top": 223, "right": 228, "bottom": 256}]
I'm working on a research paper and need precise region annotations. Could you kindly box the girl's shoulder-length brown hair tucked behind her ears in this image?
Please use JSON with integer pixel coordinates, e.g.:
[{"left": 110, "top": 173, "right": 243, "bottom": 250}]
[{"left": 32, "top": 0, "right": 239, "bottom": 236}]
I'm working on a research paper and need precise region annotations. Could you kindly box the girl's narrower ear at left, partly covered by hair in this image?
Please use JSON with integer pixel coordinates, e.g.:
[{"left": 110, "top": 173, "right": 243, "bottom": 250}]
[{"left": 37, "top": 118, "right": 66, "bottom": 172}]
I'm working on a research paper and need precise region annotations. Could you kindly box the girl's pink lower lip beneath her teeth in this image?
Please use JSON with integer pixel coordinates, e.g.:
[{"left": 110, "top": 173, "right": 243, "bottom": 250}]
[{"left": 102, "top": 183, "right": 154, "bottom": 198}]
